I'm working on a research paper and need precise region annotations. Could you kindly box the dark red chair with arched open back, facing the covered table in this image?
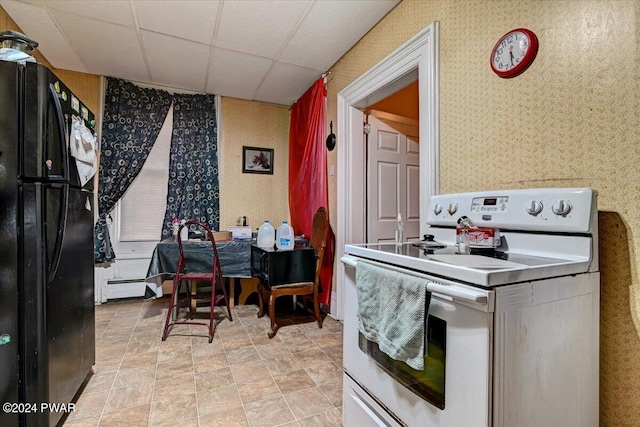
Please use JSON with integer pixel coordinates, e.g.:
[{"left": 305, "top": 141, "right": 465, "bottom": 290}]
[{"left": 162, "top": 221, "right": 233, "bottom": 343}]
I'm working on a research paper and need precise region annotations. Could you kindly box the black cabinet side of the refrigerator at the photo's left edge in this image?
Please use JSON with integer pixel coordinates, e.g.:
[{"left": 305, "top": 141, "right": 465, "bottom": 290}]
[{"left": 0, "top": 61, "right": 20, "bottom": 426}]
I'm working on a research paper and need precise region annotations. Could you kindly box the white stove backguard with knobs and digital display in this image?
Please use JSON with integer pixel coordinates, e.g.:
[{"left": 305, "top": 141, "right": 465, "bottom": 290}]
[{"left": 427, "top": 188, "right": 597, "bottom": 233}]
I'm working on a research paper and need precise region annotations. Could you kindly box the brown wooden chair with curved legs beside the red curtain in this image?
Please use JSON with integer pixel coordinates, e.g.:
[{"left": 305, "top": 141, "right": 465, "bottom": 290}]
[{"left": 258, "top": 207, "right": 331, "bottom": 338}]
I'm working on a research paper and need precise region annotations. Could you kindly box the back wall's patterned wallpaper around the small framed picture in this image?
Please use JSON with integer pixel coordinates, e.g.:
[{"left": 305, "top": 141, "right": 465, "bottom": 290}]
[{"left": 219, "top": 97, "right": 289, "bottom": 234}]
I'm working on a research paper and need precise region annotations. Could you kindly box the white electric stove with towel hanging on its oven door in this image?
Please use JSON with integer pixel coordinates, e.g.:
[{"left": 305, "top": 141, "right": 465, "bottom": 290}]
[{"left": 342, "top": 188, "right": 599, "bottom": 427}]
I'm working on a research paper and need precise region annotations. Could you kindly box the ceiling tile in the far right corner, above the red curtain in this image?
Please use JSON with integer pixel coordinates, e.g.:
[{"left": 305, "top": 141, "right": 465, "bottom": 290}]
[{"left": 255, "top": 62, "right": 322, "bottom": 105}]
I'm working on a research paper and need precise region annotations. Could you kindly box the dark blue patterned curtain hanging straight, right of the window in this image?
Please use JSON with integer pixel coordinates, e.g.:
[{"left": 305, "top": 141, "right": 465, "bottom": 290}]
[{"left": 162, "top": 94, "right": 220, "bottom": 239}]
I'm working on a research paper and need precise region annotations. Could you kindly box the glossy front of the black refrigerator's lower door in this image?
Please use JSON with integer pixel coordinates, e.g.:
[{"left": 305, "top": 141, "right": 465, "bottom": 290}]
[{"left": 45, "top": 186, "right": 95, "bottom": 425}]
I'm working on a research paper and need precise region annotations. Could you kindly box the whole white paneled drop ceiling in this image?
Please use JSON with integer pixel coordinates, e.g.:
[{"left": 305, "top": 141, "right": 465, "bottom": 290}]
[{"left": 0, "top": 0, "right": 400, "bottom": 105}]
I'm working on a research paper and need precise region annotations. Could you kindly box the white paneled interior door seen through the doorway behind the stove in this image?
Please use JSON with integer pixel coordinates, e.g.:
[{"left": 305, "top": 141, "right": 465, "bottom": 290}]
[{"left": 367, "top": 116, "right": 420, "bottom": 242}]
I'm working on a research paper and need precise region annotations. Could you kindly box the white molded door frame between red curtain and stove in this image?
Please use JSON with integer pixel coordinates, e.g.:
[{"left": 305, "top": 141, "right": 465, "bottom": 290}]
[{"left": 331, "top": 21, "right": 440, "bottom": 319}]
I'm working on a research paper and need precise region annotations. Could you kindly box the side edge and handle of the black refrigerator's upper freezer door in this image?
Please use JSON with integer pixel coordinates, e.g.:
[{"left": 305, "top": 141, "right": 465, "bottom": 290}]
[{"left": 22, "top": 63, "right": 70, "bottom": 182}]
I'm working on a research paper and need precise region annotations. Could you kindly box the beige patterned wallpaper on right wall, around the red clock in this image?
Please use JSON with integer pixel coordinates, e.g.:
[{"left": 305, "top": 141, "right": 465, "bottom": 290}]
[{"left": 327, "top": 0, "right": 640, "bottom": 426}]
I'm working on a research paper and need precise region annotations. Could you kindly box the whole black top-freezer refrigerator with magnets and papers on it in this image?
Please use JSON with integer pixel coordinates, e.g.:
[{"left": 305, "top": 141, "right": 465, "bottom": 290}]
[{"left": 0, "top": 60, "right": 95, "bottom": 427}]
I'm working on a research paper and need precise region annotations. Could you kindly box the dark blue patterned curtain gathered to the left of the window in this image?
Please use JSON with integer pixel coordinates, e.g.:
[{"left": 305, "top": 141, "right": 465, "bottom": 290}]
[{"left": 94, "top": 77, "right": 172, "bottom": 263}]
